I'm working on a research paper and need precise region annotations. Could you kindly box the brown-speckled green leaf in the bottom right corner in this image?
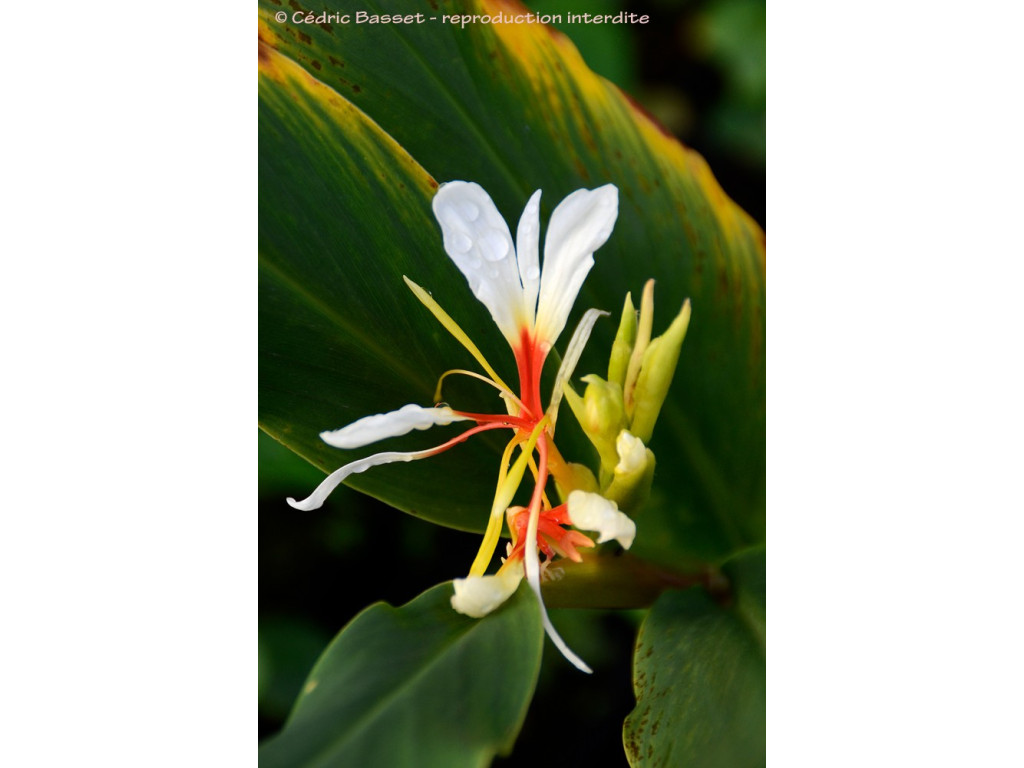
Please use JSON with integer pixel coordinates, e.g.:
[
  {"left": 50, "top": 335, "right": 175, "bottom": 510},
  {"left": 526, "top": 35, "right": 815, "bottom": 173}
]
[{"left": 623, "top": 549, "right": 765, "bottom": 768}]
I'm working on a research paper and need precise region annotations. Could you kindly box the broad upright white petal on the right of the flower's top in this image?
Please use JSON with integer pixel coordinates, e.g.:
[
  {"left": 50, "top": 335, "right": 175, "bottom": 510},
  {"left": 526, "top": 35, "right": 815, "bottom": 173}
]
[{"left": 537, "top": 184, "right": 618, "bottom": 344}]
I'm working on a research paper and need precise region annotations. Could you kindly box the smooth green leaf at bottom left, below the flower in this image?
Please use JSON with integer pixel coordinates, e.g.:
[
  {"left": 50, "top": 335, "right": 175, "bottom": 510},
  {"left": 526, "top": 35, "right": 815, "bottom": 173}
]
[{"left": 260, "top": 583, "right": 544, "bottom": 768}]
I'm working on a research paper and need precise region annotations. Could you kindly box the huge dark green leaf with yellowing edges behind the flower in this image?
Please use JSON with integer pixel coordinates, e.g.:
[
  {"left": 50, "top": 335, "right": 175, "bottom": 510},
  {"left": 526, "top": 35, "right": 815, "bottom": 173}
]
[{"left": 260, "top": 0, "right": 765, "bottom": 564}]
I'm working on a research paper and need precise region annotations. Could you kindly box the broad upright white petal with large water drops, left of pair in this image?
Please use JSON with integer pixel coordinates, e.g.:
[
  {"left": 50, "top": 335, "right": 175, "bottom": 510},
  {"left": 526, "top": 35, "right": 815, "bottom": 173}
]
[{"left": 433, "top": 181, "right": 525, "bottom": 346}]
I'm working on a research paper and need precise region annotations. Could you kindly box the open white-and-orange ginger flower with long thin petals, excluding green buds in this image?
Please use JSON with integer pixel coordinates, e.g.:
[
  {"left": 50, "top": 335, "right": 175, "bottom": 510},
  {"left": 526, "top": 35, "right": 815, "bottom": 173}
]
[{"left": 288, "top": 181, "right": 636, "bottom": 672}]
